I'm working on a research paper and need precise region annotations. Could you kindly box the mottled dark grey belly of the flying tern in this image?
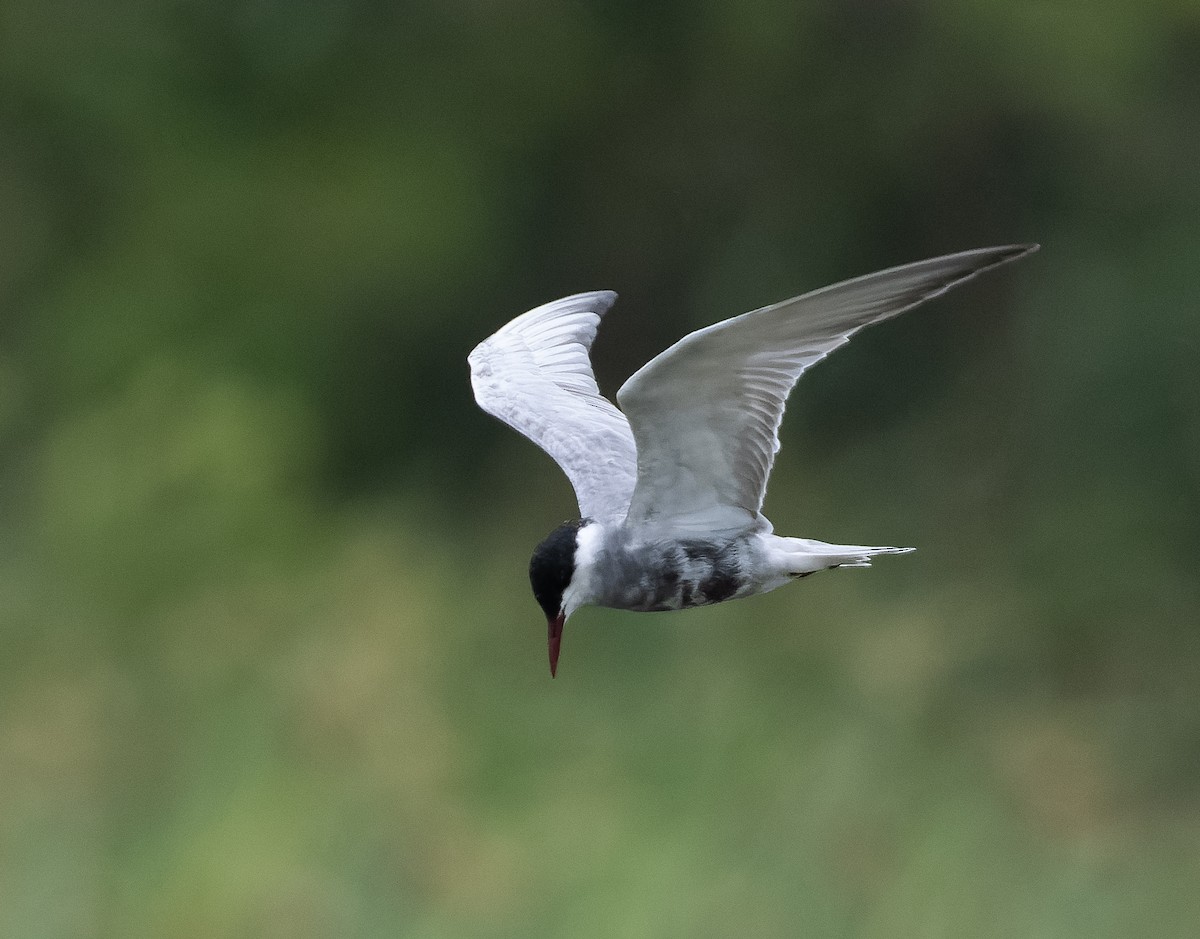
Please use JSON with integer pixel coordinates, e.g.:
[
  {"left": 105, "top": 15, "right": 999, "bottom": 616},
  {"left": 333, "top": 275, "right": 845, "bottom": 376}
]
[{"left": 604, "top": 540, "right": 746, "bottom": 612}]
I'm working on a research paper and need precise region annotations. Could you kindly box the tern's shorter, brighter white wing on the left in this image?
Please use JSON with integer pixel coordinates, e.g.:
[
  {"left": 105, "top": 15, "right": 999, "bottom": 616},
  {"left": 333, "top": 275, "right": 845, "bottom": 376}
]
[{"left": 467, "top": 291, "right": 637, "bottom": 519}]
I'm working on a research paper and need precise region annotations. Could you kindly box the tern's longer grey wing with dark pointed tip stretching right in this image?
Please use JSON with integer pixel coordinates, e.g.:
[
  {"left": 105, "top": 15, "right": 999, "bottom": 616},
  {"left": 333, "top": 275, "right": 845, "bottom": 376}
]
[{"left": 617, "top": 245, "right": 1037, "bottom": 531}]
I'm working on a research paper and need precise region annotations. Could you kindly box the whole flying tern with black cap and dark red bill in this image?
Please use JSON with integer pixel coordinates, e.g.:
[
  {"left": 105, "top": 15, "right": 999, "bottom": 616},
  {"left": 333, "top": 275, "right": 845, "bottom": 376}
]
[{"left": 468, "top": 245, "right": 1038, "bottom": 677}]
